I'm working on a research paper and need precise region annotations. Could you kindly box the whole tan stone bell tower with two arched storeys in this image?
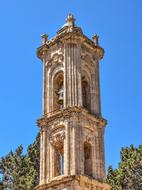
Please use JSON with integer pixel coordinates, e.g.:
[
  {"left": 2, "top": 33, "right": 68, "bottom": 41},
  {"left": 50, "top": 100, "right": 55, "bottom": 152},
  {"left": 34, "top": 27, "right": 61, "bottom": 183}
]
[{"left": 36, "top": 14, "right": 110, "bottom": 190}]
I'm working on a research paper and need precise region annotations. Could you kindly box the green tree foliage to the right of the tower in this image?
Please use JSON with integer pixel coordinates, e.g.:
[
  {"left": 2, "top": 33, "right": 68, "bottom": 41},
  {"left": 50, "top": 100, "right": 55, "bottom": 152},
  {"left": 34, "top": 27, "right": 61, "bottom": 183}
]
[{"left": 107, "top": 145, "right": 142, "bottom": 190}]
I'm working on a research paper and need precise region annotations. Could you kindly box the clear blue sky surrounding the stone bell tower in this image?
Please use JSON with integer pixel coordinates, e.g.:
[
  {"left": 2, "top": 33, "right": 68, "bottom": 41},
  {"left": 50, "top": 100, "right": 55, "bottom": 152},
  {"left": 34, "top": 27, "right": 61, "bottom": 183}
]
[{"left": 0, "top": 0, "right": 142, "bottom": 167}]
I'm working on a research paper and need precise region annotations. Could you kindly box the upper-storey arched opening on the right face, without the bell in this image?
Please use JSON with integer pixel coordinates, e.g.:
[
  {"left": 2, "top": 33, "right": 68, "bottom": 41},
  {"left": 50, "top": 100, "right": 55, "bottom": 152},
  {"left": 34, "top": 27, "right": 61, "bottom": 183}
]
[{"left": 82, "top": 76, "right": 91, "bottom": 111}]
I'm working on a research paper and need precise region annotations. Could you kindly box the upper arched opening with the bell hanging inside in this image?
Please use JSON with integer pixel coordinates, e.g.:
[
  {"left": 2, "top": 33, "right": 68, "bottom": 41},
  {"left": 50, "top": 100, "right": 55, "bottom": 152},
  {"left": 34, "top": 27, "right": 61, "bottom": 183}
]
[{"left": 53, "top": 72, "right": 64, "bottom": 111}]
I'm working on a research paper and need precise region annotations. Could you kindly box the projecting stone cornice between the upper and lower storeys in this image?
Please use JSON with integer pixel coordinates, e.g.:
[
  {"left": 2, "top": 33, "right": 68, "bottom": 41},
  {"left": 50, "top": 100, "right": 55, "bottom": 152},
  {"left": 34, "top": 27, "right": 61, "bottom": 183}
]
[{"left": 37, "top": 107, "right": 107, "bottom": 128}]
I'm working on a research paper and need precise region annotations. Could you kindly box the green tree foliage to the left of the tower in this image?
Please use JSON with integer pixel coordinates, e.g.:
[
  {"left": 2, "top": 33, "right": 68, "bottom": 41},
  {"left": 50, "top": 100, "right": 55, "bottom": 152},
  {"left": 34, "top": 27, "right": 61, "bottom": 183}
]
[{"left": 0, "top": 134, "right": 39, "bottom": 190}]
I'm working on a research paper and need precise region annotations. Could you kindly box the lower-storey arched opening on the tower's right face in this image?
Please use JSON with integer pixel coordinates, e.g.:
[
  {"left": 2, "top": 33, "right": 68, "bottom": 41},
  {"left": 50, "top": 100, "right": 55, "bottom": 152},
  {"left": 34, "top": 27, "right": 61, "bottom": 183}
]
[{"left": 84, "top": 142, "right": 92, "bottom": 176}]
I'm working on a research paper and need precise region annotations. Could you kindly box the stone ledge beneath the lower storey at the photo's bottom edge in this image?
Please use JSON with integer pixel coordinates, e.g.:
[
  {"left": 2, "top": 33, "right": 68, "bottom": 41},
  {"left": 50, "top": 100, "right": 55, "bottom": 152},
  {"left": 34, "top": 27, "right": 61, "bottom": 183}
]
[{"left": 35, "top": 175, "right": 111, "bottom": 190}]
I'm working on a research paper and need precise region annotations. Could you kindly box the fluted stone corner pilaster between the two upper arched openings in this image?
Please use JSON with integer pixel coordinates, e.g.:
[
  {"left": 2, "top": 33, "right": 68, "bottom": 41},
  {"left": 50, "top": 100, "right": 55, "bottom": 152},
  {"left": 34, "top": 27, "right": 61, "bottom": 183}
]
[{"left": 63, "top": 39, "right": 82, "bottom": 107}]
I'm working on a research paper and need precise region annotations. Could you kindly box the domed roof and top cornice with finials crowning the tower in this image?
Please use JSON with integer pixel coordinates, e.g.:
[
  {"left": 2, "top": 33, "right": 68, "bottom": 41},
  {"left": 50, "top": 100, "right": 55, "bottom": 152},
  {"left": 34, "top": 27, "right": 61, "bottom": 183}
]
[{"left": 37, "top": 13, "right": 104, "bottom": 59}]
